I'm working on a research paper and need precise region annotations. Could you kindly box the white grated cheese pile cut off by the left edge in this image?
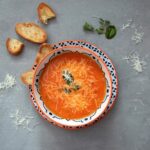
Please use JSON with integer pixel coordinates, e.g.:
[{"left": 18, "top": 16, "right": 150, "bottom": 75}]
[{"left": 0, "top": 74, "right": 16, "bottom": 91}]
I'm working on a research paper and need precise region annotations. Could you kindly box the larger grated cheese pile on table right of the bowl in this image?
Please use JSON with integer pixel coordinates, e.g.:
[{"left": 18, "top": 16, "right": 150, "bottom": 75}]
[{"left": 123, "top": 53, "right": 146, "bottom": 73}]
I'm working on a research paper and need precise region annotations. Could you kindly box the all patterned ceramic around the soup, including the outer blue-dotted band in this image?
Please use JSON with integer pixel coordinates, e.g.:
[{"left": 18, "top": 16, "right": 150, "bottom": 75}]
[{"left": 29, "top": 41, "right": 118, "bottom": 129}]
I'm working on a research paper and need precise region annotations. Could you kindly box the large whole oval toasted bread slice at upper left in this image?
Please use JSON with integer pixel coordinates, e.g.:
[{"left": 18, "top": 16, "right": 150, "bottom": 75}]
[{"left": 15, "top": 22, "right": 47, "bottom": 43}]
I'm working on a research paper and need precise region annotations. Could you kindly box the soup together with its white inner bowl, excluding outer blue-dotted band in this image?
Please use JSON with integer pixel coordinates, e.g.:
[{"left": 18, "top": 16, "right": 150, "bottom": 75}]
[{"left": 32, "top": 47, "right": 112, "bottom": 128}]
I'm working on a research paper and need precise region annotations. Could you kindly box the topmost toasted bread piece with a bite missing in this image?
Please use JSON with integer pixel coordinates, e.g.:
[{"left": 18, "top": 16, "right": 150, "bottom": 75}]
[{"left": 37, "top": 2, "right": 56, "bottom": 24}]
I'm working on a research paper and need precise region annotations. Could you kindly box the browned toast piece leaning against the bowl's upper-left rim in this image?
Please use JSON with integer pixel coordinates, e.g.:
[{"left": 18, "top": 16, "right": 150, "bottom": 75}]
[{"left": 35, "top": 43, "right": 53, "bottom": 64}]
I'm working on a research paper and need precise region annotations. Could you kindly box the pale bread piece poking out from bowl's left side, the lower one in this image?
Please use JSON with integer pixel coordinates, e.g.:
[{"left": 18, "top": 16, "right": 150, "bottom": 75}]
[{"left": 21, "top": 70, "right": 35, "bottom": 85}]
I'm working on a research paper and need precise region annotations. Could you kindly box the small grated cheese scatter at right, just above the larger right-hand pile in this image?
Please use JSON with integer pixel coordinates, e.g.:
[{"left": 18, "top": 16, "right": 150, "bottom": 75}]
[{"left": 131, "top": 29, "right": 144, "bottom": 44}]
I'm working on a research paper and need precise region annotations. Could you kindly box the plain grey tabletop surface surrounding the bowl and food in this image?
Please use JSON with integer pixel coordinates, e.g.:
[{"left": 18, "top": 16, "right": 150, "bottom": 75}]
[{"left": 0, "top": 0, "right": 150, "bottom": 150}]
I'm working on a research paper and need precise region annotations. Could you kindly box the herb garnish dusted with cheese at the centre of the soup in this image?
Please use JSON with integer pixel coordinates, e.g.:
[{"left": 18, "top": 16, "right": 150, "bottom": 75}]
[{"left": 62, "top": 70, "right": 80, "bottom": 94}]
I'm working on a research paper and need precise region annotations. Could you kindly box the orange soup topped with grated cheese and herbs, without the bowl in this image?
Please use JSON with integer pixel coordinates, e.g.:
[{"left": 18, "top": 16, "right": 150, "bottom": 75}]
[{"left": 39, "top": 52, "right": 106, "bottom": 119}]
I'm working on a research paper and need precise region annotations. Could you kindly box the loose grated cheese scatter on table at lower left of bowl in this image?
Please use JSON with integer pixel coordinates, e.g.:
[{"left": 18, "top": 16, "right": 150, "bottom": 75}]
[{"left": 10, "top": 109, "right": 39, "bottom": 132}]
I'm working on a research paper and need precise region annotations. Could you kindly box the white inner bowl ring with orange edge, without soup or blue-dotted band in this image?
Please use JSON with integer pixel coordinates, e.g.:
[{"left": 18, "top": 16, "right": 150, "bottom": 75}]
[{"left": 32, "top": 43, "right": 112, "bottom": 129}]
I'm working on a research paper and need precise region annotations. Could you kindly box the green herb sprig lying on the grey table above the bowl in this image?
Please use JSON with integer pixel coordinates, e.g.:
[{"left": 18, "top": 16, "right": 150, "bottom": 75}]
[{"left": 83, "top": 17, "right": 117, "bottom": 39}]
